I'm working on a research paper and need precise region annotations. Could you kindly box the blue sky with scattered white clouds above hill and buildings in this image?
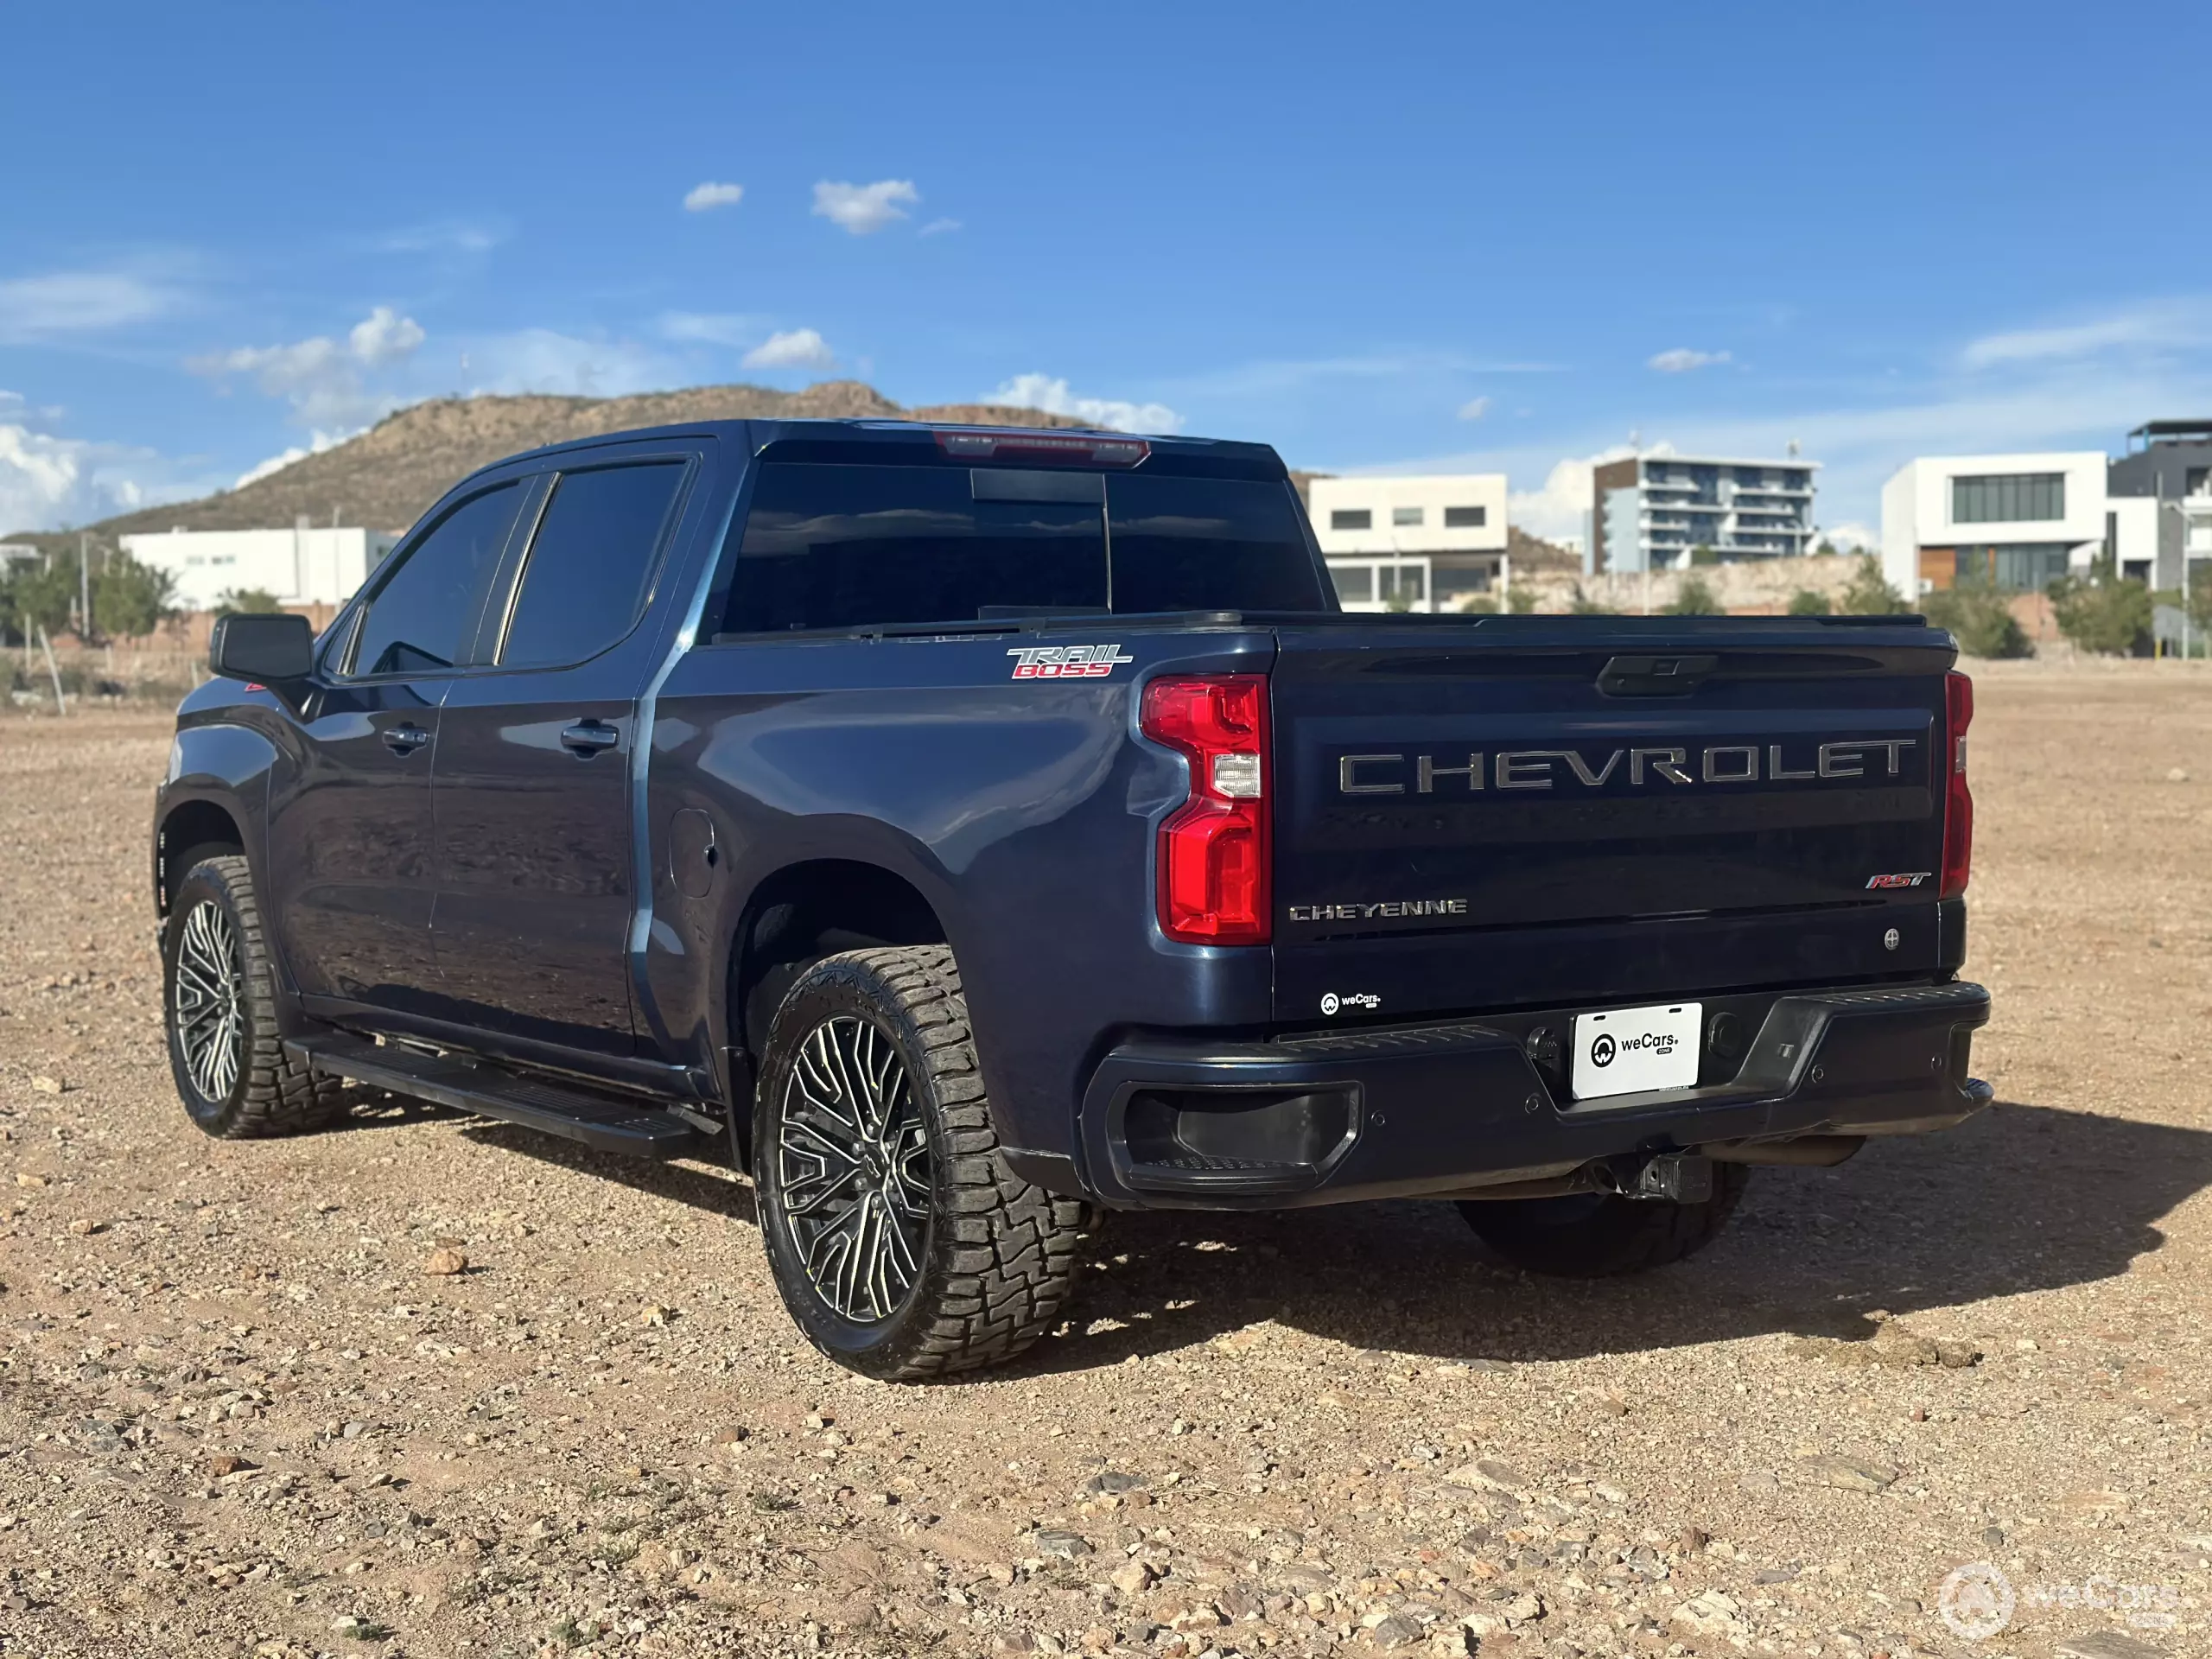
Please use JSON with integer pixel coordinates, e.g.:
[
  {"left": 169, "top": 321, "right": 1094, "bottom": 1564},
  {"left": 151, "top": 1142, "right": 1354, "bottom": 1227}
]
[{"left": 0, "top": 0, "right": 2212, "bottom": 546}]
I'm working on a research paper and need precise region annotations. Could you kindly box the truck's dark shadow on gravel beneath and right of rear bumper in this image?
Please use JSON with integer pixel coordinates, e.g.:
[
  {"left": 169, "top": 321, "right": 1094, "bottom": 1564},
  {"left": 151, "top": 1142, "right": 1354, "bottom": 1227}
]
[{"left": 1024, "top": 1103, "right": 2212, "bottom": 1370}]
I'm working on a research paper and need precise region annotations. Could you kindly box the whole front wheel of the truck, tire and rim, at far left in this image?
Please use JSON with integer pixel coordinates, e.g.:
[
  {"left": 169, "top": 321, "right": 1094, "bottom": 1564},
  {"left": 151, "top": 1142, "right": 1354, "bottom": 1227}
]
[{"left": 162, "top": 854, "right": 345, "bottom": 1139}]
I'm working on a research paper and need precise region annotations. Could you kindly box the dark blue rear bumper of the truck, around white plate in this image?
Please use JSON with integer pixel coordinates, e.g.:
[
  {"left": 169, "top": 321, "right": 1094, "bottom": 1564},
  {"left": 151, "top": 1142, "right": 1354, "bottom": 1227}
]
[{"left": 1061, "top": 984, "right": 1991, "bottom": 1210}]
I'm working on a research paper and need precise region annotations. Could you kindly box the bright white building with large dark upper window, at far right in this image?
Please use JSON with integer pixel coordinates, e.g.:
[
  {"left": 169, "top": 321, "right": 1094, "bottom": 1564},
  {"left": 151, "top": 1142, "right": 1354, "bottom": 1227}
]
[{"left": 1883, "top": 449, "right": 2159, "bottom": 600}]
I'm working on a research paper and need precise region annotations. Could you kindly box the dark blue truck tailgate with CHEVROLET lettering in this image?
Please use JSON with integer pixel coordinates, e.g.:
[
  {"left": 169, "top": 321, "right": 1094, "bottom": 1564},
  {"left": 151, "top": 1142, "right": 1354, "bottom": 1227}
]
[{"left": 1272, "top": 617, "right": 1955, "bottom": 1020}]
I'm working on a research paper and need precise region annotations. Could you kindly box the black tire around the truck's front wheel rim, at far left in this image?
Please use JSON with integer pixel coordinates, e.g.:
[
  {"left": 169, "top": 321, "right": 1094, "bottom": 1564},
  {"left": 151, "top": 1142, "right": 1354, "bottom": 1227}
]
[{"left": 162, "top": 854, "right": 345, "bottom": 1141}]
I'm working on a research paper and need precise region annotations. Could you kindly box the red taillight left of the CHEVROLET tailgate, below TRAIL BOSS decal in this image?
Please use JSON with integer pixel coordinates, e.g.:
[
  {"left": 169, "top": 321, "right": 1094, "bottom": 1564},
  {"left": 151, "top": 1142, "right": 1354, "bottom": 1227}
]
[{"left": 1141, "top": 675, "right": 1272, "bottom": 944}]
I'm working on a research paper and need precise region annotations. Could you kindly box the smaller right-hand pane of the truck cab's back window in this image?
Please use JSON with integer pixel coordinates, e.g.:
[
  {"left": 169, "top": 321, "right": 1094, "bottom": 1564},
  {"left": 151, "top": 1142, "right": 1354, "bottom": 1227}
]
[{"left": 1106, "top": 474, "right": 1334, "bottom": 611}]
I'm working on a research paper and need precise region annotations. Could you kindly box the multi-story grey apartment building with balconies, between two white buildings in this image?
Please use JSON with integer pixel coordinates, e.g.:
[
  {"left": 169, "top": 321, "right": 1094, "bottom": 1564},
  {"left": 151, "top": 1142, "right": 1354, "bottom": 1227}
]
[{"left": 1581, "top": 455, "right": 1821, "bottom": 575}]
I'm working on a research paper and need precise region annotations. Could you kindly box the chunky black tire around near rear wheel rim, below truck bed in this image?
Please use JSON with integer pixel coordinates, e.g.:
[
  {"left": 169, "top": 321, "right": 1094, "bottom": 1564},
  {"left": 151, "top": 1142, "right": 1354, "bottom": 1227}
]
[{"left": 752, "top": 944, "right": 1086, "bottom": 1382}]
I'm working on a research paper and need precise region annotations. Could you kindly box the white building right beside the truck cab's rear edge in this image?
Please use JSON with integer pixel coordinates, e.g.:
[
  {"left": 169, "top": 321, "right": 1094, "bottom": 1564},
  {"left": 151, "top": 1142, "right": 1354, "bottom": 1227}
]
[{"left": 1307, "top": 474, "right": 1510, "bottom": 611}]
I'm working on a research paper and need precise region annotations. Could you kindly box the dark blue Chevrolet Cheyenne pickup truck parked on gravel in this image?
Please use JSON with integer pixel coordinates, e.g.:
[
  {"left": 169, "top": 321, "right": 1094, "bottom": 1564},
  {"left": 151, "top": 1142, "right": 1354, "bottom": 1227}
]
[{"left": 153, "top": 420, "right": 1991, "bottom": 1378}]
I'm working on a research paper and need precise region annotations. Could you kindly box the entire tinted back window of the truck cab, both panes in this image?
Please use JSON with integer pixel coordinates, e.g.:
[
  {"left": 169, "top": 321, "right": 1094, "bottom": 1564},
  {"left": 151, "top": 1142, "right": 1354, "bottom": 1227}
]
[{"left": 726, "top": 462, "right": 1323, "bottom": 632}]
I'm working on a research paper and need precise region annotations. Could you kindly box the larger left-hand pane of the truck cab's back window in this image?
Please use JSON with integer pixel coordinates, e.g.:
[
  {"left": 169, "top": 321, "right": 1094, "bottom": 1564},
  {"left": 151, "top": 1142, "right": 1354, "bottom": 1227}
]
[{"left": 726, "top": 460, "right": 1106, "bottom": 632}]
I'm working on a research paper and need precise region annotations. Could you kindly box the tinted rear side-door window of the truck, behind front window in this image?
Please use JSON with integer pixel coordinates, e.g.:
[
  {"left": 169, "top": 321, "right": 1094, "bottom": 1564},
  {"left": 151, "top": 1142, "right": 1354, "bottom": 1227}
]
[{"left": 500, "top": 460, "right": 683, "bottom": 668}]
